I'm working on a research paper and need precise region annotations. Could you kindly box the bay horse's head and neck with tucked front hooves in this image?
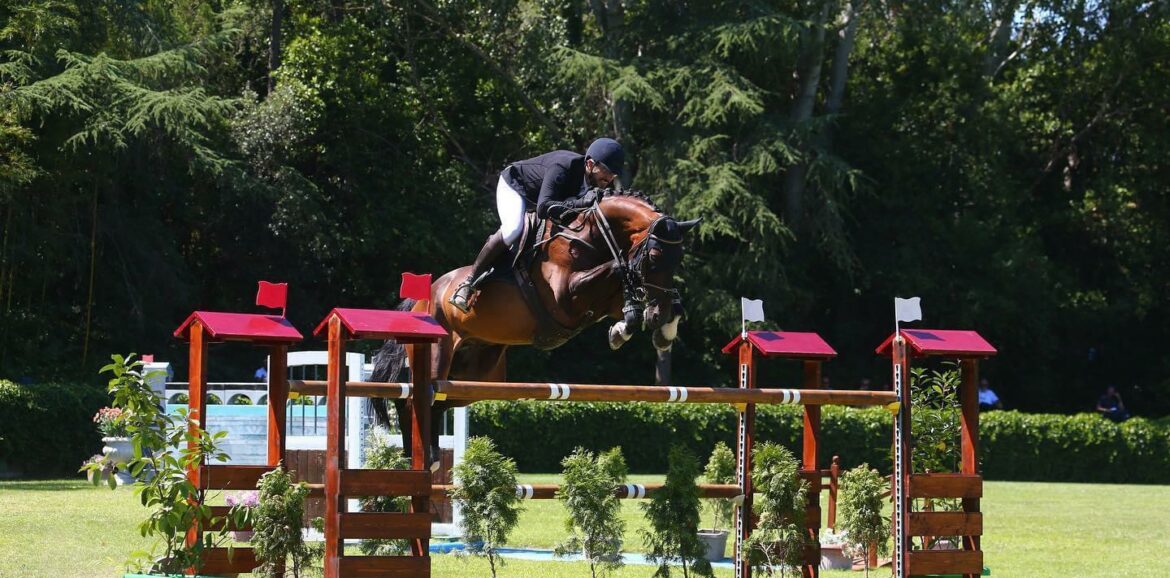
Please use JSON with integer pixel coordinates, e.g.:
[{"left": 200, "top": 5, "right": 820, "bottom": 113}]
[{"left": 601, "top": 193, "right": 698, "bottom": 350}]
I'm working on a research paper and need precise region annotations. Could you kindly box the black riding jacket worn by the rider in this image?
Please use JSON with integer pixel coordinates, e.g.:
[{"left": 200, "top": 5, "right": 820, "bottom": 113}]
[{"left": 501, "top": 151, "right": 589, "bottom": 219}]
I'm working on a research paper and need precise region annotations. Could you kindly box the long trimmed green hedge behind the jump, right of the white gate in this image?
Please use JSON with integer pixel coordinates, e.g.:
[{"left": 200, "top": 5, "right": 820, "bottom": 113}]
[{"left": 470, "top": 401, "right": 1170, "bottom": 483}]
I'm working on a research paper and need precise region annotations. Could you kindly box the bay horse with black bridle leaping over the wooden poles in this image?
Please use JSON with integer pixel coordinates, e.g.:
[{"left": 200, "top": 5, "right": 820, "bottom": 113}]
[{"left": 371, "top": 190, "right": 700, "bottom": 460}]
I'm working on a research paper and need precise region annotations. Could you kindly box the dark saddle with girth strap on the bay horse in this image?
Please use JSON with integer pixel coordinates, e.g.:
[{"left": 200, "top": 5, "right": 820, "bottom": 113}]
[{"left": 484, "top": 212, "right": 594, "bottom": 350}]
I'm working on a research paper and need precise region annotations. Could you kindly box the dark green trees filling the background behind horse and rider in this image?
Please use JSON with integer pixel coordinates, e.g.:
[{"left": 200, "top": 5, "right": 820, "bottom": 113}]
[{"left": 0, "top": 0, "right": 1170, "bottom": 415}]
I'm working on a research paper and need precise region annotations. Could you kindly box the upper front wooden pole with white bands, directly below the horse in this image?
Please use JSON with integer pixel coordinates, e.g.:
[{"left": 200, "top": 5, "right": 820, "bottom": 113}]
[{"left": 435, "top": 380, "right": 897, "bottom": 406}]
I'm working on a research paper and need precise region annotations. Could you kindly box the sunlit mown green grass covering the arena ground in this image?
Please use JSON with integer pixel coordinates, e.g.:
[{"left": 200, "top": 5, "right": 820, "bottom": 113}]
[{"left": 0, "top": 475, "right": 1170, "bottom": 578}]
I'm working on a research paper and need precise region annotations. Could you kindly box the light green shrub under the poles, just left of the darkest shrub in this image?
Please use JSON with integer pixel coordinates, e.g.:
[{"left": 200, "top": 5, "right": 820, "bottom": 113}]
[{"left": 555, "top": 447, "right": 628, "bottom": 578}]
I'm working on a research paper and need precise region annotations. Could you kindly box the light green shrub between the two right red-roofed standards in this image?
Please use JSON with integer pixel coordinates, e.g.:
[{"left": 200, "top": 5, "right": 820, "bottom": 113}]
[{"left": 839, "top": 463, "right": 889, "bottom": 577}]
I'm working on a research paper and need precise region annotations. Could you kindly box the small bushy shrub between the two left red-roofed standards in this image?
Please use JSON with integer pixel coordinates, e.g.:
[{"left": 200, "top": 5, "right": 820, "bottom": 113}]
[{"left": 249, "top": 467, "right": 314, "bottom": 578}]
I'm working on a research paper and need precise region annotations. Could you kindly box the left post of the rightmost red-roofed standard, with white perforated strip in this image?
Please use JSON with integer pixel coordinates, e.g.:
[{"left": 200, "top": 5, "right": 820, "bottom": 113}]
[{"left": 890, "top": 333, "right": 910, "bottom": 578}]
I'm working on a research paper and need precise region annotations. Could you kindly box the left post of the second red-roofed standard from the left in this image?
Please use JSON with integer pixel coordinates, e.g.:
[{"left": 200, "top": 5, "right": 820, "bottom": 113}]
[{"left": 324, "top": 315, "right": 345, "bottom": 578}]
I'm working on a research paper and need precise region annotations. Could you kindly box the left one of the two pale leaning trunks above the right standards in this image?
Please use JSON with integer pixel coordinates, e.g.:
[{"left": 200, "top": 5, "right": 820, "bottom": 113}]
[{"left": 784, "top": 2, "right": 834, "bottom": 232}]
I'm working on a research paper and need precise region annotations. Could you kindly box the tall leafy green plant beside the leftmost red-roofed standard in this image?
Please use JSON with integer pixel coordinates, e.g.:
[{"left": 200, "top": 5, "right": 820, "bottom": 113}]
[{"left": 82, "top": 355, "right": 246, "bottom": 574}]
